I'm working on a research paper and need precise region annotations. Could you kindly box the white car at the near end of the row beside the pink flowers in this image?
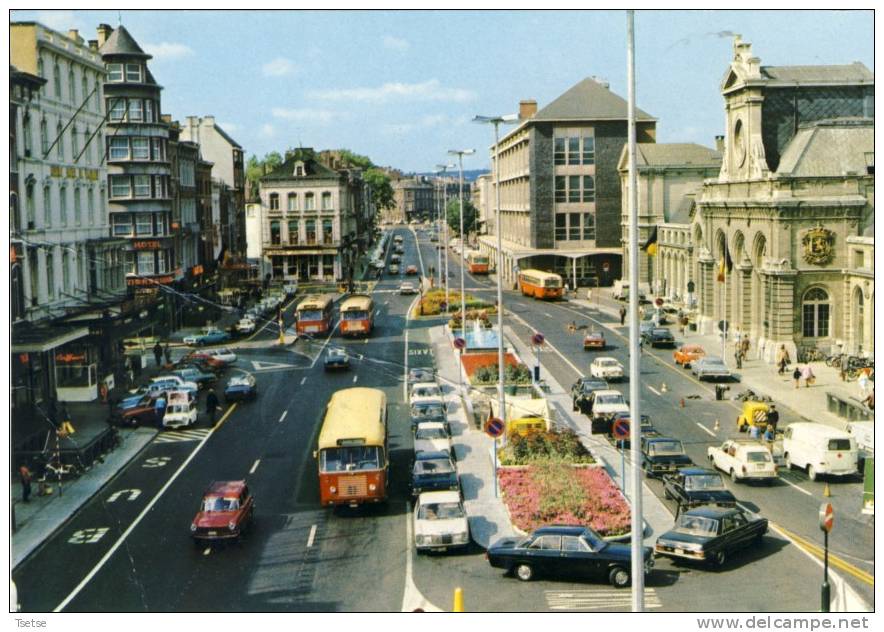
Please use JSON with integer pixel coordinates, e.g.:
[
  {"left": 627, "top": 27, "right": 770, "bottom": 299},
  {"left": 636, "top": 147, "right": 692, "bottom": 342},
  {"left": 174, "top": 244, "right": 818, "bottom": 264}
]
[{"left": 413, "top": 491, "right": 470, "bottom": 553}]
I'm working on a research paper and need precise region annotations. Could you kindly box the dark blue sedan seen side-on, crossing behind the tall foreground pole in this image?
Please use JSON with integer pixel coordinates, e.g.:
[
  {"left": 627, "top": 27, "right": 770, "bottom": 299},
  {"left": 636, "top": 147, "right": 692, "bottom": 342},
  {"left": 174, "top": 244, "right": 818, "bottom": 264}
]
[{"left": 485, "top": 526, "right": 654, "bottom": 588}]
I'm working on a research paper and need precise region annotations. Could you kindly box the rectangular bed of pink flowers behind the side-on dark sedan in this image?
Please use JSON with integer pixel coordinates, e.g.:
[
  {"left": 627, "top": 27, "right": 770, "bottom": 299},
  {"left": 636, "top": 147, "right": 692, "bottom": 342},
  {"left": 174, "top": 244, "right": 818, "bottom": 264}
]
[{"left": 498, "top": 461, "right": 631, "bottom": 537}]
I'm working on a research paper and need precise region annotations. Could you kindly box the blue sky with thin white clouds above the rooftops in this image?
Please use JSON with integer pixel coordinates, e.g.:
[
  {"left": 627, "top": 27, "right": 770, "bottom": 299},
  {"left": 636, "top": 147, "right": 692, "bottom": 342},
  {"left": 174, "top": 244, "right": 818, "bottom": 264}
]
[{"left": 12, "top": 10, "right": 874, "bottom": 171}]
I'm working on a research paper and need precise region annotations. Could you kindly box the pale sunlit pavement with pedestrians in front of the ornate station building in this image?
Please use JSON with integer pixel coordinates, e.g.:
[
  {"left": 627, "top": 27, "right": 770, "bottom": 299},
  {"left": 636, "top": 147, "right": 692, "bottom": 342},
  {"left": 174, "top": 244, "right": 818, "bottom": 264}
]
[{"left": 570, "top": 288, "right": 864, "bottom": 429}]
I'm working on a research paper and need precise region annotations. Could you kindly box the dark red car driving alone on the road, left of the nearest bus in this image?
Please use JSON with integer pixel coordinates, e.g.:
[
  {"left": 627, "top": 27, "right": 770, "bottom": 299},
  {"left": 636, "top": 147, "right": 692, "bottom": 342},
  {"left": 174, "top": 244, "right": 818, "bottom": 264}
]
[{"left": 190, "top": 481, "right": 255, "bottom": 545}]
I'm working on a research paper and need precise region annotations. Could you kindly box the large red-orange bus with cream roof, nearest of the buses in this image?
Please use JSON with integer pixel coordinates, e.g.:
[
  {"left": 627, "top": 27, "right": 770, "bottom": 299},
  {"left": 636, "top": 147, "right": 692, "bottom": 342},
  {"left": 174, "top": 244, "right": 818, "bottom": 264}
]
[{"left": 314, "top": 388, "right": 390, "bottom": 507}]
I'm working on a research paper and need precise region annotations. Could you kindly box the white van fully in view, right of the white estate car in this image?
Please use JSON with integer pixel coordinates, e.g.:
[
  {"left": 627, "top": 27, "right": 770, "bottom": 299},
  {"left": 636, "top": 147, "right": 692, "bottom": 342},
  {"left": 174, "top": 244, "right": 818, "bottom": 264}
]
[{"left": 783, "top": 422, "right": 858, "bottom": 481}]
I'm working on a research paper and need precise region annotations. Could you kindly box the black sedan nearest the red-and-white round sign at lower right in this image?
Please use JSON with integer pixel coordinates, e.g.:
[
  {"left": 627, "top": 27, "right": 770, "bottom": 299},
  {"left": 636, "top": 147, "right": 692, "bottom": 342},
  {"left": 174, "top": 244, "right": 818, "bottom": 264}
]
[{"left": 654, "top": 506, "right": 767, "bottom": 567}]
